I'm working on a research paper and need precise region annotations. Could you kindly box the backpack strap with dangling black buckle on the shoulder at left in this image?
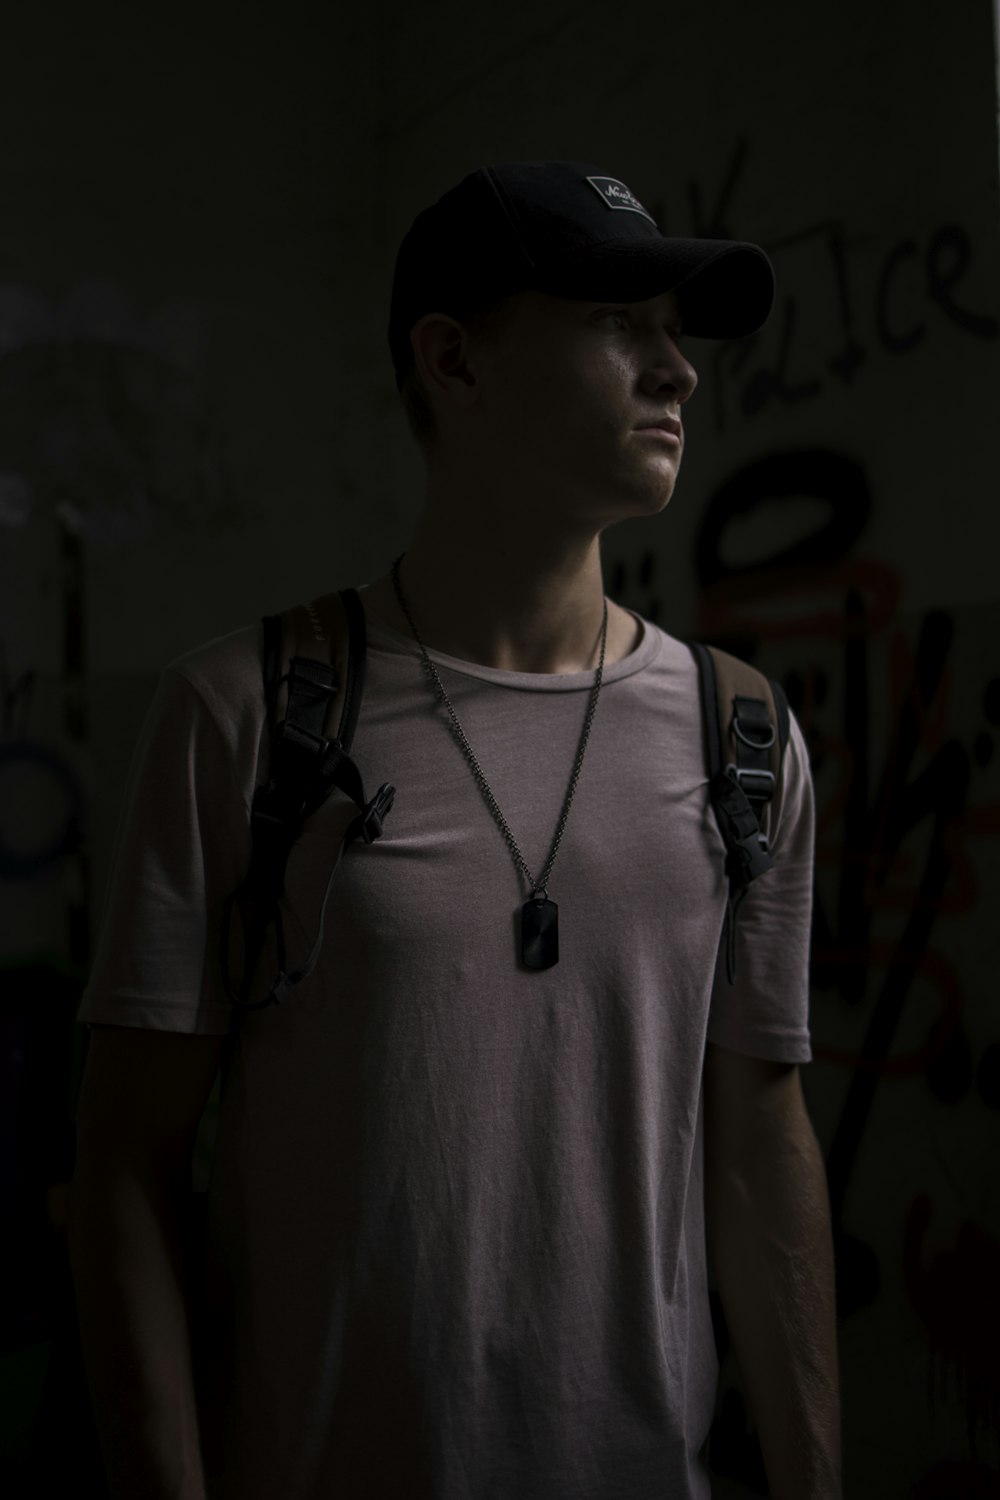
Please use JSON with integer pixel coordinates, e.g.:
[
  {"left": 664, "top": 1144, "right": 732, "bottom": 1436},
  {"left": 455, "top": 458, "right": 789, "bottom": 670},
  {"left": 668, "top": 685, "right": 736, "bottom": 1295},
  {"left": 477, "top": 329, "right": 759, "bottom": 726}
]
[{"left": 222, "top": 590, "right": 396, "bottom": 1010}]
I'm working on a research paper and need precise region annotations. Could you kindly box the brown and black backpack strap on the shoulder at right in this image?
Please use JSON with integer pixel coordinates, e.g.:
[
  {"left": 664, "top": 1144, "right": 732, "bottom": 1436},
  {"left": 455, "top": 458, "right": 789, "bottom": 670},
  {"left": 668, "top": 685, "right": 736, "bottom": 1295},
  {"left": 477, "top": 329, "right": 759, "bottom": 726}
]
[{"left": 691, "top": 642, "right": 790, "bottom": 984}]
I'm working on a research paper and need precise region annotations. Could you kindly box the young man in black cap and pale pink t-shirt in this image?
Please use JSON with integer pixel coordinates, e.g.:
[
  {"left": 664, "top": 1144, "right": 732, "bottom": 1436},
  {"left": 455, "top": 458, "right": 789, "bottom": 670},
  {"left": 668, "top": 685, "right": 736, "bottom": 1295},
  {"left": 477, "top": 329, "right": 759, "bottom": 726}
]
[{"left": 72, "top": 162, "right": 840, "bottom": 1500}]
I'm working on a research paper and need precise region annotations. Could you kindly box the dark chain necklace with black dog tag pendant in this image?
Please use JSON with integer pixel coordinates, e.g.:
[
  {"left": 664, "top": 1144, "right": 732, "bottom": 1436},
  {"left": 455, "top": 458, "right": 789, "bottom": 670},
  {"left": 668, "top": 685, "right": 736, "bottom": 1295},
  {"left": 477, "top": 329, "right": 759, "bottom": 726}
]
[{"left": 393, "top": 552, "right": 607, "bottom": 969}]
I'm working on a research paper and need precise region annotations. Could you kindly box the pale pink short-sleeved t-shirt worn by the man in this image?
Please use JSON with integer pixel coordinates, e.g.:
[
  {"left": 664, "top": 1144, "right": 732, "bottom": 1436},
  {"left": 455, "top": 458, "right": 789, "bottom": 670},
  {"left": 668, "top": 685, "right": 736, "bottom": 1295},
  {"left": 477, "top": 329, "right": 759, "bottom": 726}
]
[{"left": 79, "top": 594, "right": 813, "bottom": 1500}]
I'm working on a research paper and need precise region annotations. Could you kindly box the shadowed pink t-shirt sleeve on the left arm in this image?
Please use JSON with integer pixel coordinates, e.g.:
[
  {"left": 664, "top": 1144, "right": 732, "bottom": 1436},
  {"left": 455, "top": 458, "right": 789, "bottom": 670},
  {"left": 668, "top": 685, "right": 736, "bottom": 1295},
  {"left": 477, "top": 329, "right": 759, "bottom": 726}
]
[{"left": 79, "top": 668, "right": 250, "bottom": 1035}]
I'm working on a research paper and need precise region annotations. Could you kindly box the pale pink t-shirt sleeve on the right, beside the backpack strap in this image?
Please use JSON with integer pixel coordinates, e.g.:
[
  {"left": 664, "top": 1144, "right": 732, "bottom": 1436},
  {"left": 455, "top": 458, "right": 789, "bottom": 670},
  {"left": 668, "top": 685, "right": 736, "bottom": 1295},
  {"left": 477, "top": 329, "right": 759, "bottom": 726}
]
[{"left": 708, "top": 716, "right": 816, "bottom": 1062}]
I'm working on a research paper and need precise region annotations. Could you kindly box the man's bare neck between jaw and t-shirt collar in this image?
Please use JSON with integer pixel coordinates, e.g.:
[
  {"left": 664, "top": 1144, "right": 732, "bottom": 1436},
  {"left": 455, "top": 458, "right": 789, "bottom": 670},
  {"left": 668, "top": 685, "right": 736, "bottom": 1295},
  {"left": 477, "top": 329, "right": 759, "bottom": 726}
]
[{"left": 366, "top": 519, "right": 642, "bottom": 674}]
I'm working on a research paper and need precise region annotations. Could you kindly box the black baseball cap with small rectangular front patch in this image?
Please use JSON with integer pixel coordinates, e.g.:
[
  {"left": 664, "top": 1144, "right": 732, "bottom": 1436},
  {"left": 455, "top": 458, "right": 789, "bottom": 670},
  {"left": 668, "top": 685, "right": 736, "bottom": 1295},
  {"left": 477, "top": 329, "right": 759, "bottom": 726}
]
[{"left": 388, "top": 162, "right": 774, "bottom": 386}]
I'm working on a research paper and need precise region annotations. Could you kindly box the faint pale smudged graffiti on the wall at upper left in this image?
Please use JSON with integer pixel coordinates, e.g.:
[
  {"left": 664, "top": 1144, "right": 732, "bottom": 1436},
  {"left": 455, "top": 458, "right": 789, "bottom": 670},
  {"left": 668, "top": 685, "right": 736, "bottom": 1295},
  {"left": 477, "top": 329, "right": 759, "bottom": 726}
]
[{"left": 0, "top": 282, "right": 237, "bottom": 543}]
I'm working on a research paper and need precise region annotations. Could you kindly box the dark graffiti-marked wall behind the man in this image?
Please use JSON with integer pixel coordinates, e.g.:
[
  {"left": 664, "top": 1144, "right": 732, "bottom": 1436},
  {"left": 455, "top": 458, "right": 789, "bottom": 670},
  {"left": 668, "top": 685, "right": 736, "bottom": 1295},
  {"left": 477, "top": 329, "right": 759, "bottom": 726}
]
[{"left": 0, "top": 0, "right": 1000, "bottom": 1500}]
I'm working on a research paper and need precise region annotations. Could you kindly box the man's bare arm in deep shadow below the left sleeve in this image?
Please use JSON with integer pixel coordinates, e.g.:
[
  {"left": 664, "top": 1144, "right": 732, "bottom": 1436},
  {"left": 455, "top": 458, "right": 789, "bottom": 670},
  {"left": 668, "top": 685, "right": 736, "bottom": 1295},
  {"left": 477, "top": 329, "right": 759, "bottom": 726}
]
[{"left": 69, "top": 1026, "right": 226, "bottom": 1500}]
